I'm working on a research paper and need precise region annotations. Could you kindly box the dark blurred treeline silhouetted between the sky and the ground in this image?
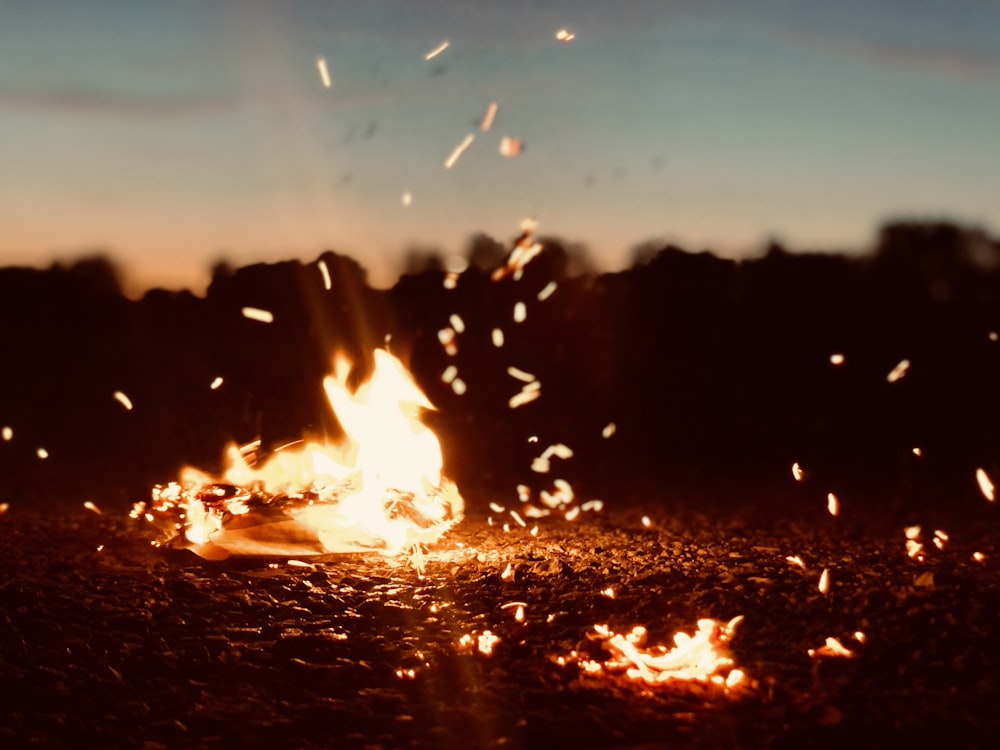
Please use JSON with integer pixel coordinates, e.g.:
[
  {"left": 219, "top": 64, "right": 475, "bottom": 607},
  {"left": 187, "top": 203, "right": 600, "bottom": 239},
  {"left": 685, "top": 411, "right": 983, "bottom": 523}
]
[{"left": 0, "top": 222, "right": 1000, "bottom": 516}]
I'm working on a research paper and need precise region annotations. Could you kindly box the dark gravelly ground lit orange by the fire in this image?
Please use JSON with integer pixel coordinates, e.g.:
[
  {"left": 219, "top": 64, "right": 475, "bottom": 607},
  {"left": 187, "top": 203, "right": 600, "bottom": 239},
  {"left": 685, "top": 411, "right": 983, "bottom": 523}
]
[{"left": 0, "top": 494, "right": 1000, "bottom": 749}]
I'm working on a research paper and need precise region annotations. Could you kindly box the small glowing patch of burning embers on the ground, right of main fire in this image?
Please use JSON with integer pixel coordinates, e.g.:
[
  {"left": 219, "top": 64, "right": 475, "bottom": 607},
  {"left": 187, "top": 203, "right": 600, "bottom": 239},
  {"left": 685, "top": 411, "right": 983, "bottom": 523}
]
[{"left": 557, "top": 615, "right": 747, "bottom": 689}]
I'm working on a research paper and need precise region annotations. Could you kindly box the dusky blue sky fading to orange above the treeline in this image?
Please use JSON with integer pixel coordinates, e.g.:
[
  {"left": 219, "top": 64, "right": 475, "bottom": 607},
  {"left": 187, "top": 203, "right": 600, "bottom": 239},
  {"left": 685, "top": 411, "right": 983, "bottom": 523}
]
[{"left": 0, "top": 0, "right": 1000, "bottom": 291}]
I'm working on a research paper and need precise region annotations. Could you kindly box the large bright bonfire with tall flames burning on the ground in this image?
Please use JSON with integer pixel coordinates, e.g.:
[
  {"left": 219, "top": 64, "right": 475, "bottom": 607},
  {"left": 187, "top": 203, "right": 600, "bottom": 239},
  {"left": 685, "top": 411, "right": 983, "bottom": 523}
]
[{"left": 131, "top": 349, "right": 464, "bottom": 569}]
